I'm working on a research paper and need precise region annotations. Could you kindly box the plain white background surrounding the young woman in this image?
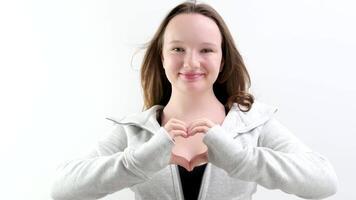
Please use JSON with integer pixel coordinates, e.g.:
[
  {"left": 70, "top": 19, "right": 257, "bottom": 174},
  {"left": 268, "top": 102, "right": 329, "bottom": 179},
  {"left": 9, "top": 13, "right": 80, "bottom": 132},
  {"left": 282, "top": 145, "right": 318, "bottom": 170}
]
[{"left": 0, "top": 0, "right": 356, "bottom": 200}]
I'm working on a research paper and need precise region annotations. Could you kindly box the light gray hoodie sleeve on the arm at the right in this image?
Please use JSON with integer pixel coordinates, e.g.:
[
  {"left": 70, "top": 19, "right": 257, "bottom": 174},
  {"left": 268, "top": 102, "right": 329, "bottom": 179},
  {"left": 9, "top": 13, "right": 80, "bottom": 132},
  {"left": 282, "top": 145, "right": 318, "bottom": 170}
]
[{"left": 203, "top": 117, "right": 337, "bottom": 199}]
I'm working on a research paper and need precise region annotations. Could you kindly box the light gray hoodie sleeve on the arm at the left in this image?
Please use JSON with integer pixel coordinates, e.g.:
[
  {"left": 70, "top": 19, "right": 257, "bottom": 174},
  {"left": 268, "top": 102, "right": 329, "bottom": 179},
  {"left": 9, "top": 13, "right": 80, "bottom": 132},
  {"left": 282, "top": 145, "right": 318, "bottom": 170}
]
[{"left": 51, "top": 124, "right": 173, "bottom": 200}]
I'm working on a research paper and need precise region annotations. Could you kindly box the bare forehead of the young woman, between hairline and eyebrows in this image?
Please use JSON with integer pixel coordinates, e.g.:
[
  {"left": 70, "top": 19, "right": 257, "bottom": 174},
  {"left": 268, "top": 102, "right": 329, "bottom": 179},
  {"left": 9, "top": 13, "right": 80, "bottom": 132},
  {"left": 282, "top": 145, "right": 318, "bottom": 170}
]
[{"left": 163, "top": 13, "right": 221, "bottom": 45}]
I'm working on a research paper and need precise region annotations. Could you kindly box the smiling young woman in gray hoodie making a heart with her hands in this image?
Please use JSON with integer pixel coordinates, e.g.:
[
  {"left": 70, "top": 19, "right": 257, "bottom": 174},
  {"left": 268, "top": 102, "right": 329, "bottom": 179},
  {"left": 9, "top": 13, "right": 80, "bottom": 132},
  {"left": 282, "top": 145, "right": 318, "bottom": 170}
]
[{"left": 52, "top": 2, "right": 337, "bottom": 200}]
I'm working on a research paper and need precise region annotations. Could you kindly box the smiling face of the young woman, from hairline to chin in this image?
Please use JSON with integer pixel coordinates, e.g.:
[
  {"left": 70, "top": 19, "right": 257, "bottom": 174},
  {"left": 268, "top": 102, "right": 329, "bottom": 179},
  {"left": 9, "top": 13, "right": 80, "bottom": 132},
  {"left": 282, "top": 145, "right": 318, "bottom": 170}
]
[{"left": 162, "top": 14, "right": 222, "bottom": 93}]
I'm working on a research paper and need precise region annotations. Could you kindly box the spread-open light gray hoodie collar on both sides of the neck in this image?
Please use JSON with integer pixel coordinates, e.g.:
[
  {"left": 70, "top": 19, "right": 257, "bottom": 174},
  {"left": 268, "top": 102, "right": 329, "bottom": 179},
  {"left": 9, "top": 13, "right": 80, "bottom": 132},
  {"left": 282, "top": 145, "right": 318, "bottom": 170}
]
[{"left": 106, "top": 100, "right": 278, "bottom": 137}]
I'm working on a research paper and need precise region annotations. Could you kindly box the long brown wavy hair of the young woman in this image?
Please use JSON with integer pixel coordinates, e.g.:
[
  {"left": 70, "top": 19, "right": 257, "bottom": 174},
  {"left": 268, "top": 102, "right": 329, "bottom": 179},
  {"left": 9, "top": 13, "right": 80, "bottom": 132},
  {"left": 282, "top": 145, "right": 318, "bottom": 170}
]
[{"left": 141, "top": 2, "right": 254, "bottom": 112}]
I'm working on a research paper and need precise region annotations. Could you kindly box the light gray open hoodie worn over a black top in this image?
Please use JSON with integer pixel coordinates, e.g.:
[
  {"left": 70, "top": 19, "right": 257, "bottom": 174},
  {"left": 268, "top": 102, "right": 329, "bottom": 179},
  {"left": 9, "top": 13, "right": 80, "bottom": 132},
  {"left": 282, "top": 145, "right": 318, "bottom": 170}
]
[{"left": 51, "top": 101, "right": 337, "bottom": 200}]
